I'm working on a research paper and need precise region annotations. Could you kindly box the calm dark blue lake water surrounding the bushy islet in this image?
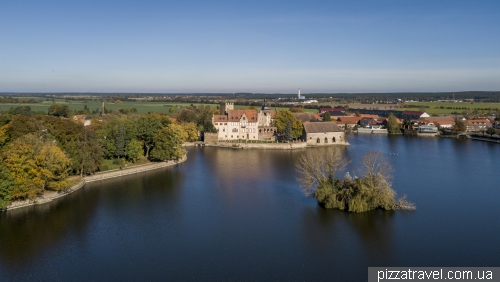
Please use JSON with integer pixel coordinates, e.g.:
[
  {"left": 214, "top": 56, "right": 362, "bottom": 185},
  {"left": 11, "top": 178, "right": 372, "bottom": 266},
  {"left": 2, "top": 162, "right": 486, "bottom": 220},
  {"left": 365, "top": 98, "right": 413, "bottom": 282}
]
[{"left": 0, "top": 135, "right": 500, "bottom": 281}]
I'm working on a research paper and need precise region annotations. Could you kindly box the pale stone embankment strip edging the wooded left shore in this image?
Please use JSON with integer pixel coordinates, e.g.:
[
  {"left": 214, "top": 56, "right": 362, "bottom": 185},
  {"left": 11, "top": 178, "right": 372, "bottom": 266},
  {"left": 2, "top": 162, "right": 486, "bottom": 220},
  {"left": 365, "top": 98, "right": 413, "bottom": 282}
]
[{"left": 5, "top": 155, "right": 187, "bottom": 211}]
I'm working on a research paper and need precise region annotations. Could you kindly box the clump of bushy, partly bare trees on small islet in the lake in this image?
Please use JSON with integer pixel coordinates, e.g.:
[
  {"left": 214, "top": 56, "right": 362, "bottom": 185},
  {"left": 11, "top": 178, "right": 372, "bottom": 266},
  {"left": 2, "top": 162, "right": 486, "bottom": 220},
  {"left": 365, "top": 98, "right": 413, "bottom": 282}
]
[{"left": 296, "top": 150, "right": 415, "bottom": 212}]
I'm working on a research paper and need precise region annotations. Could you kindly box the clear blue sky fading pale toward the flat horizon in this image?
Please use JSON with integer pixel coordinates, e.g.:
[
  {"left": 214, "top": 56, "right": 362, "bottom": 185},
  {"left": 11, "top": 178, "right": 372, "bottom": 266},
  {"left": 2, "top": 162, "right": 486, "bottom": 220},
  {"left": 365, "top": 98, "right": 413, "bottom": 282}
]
[{"left": 0, "top": 0, "right": 500, "bottom": 93}]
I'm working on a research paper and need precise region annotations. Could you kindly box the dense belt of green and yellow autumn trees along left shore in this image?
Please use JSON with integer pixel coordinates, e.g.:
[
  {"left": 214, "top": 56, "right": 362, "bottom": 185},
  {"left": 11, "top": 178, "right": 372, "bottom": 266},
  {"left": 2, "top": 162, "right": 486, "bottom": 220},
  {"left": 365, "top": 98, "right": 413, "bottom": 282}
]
[{"left": 0, "top": 106, "right": 209, "bottom": 209}]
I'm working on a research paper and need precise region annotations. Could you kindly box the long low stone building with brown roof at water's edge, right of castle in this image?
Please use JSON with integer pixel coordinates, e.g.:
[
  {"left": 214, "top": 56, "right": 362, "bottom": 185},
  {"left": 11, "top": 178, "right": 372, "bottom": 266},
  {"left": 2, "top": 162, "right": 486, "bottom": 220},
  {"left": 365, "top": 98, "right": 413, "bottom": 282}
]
[{"left": 302, "top": 122, "right": 349, "bottom": 146}]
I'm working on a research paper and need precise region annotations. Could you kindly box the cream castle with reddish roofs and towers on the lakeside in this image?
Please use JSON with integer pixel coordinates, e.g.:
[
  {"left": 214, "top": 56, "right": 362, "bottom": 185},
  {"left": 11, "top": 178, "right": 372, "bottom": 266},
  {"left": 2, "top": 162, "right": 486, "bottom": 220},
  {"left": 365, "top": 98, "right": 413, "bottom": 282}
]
[{"left": 212, "top": 100, "right": 277, "bottom": 141}]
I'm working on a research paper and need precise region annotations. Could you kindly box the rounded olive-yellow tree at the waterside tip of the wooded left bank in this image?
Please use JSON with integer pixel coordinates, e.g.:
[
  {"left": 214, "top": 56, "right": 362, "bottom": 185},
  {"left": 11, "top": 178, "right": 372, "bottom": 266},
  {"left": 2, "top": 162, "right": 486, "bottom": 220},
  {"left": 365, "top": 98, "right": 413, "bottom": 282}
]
[{"left": 151, "top": 123, "right": 186, "bottom": 161}]
